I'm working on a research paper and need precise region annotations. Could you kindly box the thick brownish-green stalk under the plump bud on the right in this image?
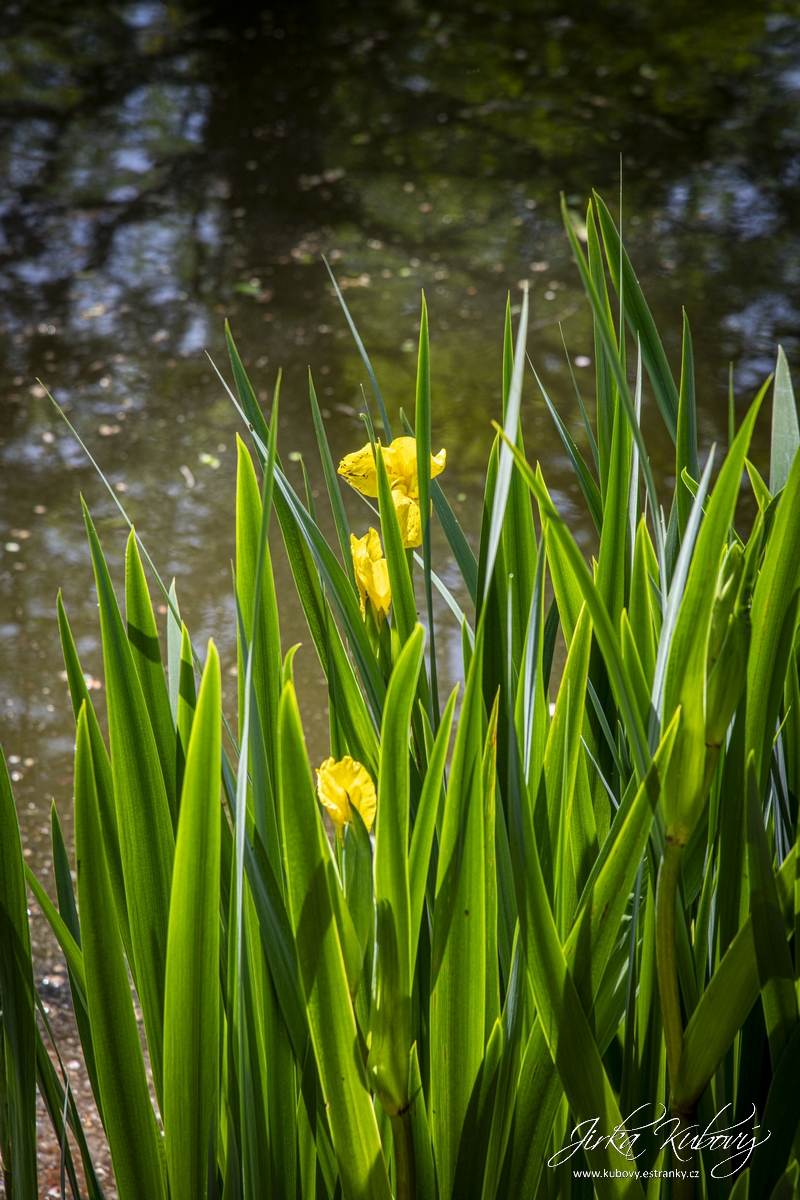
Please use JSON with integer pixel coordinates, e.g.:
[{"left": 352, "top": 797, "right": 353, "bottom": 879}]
[{"left": 656, "top": 830, "right": 694, "bottom": 1200}]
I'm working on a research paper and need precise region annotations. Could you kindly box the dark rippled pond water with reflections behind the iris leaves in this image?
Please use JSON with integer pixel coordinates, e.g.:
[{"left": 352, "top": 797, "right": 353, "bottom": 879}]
[{"left": 0, "top": 0, "right": 800, "bottom": 878}]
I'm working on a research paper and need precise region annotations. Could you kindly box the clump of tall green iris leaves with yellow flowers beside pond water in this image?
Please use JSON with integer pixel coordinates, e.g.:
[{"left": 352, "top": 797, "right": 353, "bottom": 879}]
[{"left": 0, "top": 197, "right": 800, "bottom": 1200}]
